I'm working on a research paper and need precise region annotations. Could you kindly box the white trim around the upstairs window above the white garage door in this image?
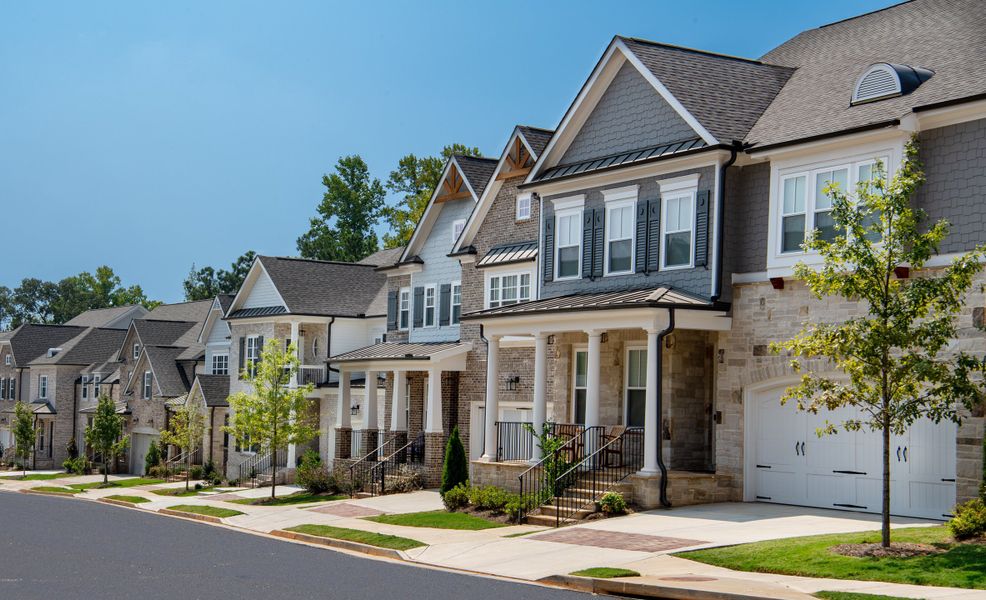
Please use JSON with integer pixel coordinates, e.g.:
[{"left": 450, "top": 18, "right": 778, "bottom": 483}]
[{"left": 767, "top": 141, "right": 906, "bottom": 277}]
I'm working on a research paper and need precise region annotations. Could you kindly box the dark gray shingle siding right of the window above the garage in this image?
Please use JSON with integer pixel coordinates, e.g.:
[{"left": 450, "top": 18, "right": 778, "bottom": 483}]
[{"left": 917, "top": 119, "right": 986, "bottom": 253}]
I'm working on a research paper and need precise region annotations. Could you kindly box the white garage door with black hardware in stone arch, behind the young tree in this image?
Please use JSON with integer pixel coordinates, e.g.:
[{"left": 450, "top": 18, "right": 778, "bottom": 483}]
[{"left": 751, "top": 387, "right": 956, "bottom": 519}]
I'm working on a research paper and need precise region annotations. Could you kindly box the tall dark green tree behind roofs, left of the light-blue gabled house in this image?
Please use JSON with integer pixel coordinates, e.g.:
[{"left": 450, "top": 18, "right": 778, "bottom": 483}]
[{"left": 298, "top": 154, "right": 385, "bottom": 262}]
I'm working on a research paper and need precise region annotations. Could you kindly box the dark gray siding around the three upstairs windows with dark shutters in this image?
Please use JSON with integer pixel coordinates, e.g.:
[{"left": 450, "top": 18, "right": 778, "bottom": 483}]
[{"left": 538, "top": 167, "right": 712, "bottom": 298}]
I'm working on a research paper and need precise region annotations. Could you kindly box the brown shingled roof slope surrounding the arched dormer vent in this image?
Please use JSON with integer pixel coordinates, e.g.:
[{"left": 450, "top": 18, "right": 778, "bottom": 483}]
[{"left": 746, "top": 0, "right": 986, "bottom": 149}]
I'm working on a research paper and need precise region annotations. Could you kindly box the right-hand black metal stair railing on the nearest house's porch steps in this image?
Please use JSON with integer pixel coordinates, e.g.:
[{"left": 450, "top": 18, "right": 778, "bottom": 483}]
[{"left": 552, "top": 427, "right": 644, "bottom": 527}]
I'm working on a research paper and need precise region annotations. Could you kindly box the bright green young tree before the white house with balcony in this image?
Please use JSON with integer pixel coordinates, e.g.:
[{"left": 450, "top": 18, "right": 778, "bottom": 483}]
[{"left": 225, "top": 339, "right": 318, "bottom": 498}]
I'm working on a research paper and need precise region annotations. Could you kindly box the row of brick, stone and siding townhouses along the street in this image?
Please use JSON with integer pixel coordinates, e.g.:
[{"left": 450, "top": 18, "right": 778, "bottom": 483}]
[{"left": 0, "top": 0, "right": 986, "bottom": 518}]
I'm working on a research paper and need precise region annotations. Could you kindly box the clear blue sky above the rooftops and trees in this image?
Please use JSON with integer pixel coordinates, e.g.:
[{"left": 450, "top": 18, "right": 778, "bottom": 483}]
[{"left": 0, "top": 0, "right": 892, "bottom": 301}]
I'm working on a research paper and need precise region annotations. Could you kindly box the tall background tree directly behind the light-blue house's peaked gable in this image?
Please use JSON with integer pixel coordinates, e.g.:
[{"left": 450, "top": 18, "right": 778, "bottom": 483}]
[{"left": 383, "top": 144, "right": 482, "bottom": 248}]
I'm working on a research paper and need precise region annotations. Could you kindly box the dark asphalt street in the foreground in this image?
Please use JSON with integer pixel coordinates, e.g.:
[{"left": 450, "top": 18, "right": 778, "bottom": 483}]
[{"left": 0, "top": 492, "right": 588, "bottom": 600}]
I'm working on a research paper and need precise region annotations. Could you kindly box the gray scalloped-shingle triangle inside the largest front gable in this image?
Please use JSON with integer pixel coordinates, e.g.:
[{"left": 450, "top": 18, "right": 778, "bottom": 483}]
[{"left": 561, "top": 63, "right": 698, "bottom": 164}]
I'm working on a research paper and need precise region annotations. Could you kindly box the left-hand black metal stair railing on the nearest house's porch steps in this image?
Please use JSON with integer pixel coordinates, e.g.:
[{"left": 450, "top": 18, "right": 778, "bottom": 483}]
[{"left": 517, "top": 423, "right": 606, "bottom": 521}]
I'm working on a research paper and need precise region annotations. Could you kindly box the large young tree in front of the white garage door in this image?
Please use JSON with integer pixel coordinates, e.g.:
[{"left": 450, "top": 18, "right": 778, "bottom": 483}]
[{"left": 773, "top": 142, "right": 984, "bottom": 547}]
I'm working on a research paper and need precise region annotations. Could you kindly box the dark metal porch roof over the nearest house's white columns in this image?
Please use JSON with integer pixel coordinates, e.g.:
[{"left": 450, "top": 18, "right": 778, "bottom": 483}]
[{"left": 462, "top": 286, "right": 726, "bottom": 320}]
